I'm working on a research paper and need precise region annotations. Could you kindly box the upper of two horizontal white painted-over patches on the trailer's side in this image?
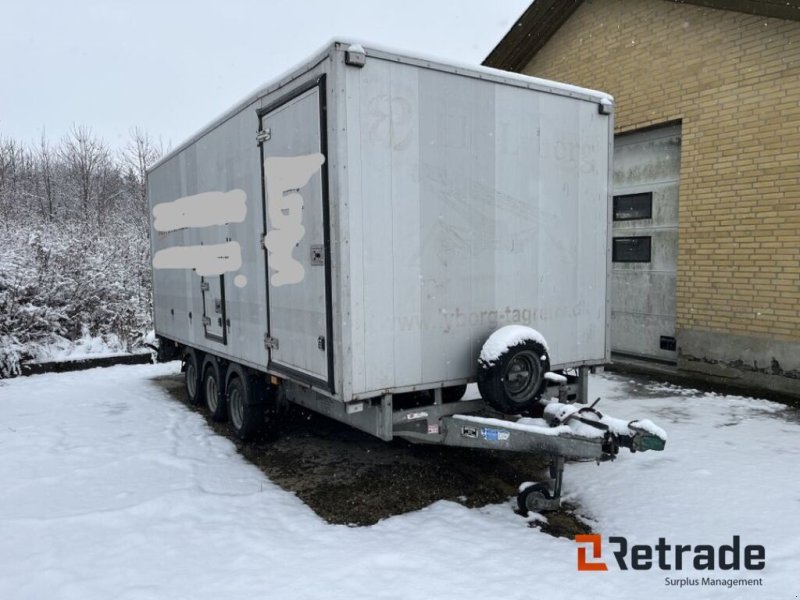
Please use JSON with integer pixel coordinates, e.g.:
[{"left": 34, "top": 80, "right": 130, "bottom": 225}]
[{"left": 153, "top": 189, "right": 247, "bottom": 231}]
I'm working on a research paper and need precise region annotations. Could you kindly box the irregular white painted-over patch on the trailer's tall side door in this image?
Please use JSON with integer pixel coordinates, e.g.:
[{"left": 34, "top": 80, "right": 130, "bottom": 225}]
[{"left": 264, "top": 152, "right": 325, "bottom": 287}]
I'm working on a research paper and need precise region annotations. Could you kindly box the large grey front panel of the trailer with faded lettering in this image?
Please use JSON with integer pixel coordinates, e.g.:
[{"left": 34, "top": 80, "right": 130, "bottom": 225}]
[{"left": 346, "top": 58, "right": 611, "bottom": 394}]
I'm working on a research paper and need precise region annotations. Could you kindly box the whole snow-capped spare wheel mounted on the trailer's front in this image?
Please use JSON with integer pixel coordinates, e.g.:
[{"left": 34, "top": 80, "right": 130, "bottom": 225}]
[{"left": 478, "top": 325, "right": 550, "bottom": 414}]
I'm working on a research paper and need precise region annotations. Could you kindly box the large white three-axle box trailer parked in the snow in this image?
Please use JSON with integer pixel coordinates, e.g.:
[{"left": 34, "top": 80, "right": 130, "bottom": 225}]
[{"left": 148, "top": 42, "right": 664, "bottom": 510}]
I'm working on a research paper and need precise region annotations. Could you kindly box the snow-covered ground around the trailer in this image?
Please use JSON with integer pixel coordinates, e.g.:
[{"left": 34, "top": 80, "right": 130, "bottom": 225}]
[{"left": 0, "top": 363, "right": 800, "bottom": 600}]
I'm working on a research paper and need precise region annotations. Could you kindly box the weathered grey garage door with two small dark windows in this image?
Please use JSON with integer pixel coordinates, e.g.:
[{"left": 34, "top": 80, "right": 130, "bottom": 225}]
[{"left": 611, "top": 125, "right": 681, "bottom": 362}]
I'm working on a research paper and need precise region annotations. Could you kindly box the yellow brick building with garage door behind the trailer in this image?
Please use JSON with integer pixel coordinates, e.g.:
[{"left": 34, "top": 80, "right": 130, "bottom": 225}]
[{"left": 484, "top": 0, "right": 800, "bottom": 394}]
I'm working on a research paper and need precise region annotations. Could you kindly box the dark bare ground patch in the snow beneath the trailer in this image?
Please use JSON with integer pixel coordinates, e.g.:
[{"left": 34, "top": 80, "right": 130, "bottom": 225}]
[{"left": 156, "top": 376, "right": 589, "bottom": 538}]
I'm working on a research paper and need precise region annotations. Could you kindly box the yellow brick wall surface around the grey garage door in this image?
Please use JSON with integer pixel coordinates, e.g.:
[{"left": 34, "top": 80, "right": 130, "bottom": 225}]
[{"left": 523, "top": 0, "right": 800, "bottom": 341}]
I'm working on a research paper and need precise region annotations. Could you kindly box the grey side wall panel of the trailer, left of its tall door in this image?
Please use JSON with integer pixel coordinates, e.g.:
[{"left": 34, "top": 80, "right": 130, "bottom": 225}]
[{"left": 148, "top": 104, "right": 267, "bottom": 368}]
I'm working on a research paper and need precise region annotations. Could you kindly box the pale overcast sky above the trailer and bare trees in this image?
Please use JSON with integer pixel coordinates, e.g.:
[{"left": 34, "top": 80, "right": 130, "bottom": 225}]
[{"left": 0, "top": 0, "right": 530, "bottom": 147}]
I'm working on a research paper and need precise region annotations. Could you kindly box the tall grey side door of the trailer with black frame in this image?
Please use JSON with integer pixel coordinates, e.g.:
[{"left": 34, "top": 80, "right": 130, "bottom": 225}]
[{"left": 258, "top": 78, "right": 333, "bottom": 390}]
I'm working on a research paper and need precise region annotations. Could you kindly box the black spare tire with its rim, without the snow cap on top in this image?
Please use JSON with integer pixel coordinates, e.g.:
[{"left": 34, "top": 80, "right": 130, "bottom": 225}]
[{"left": 478, "top": 340, "right": 550, "bottom": 415}]
